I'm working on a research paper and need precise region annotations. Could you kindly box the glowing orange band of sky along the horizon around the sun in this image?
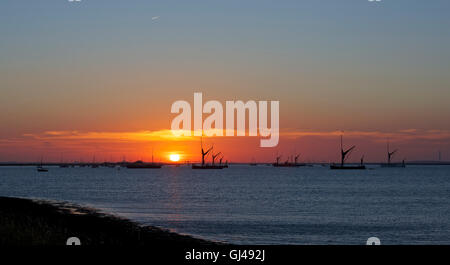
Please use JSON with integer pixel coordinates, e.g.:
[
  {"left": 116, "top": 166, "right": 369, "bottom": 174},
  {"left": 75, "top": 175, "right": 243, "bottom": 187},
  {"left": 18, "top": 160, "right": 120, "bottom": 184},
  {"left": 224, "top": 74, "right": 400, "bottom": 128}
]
[{"left": 0, "top": 128, "right": 450, "bottom": 163}]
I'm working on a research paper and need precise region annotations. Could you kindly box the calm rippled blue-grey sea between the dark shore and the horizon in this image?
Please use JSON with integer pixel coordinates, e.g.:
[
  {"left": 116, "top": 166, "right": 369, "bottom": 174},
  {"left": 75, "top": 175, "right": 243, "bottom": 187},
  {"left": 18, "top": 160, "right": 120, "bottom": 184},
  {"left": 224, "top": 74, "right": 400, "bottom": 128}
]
[{"left": 0, "top": 165, "right": 450, "bottom": 244}]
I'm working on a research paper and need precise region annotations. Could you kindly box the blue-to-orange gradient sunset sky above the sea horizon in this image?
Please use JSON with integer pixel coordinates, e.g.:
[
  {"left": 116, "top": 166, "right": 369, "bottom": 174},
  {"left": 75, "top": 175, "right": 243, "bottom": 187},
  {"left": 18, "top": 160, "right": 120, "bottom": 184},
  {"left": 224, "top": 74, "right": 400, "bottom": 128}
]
[{"left": 0, "top": 0, "right": 450, "bottom": 161}]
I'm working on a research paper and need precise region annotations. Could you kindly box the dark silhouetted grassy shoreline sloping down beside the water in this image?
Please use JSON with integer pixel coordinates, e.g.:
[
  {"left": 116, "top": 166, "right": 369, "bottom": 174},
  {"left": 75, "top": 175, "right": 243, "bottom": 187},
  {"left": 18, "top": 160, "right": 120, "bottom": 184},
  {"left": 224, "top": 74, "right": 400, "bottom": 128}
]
[{"left": 0, "top": 197, "right": 216, "bottom": 246}]
